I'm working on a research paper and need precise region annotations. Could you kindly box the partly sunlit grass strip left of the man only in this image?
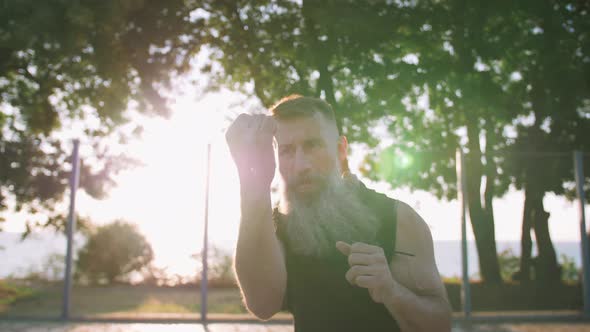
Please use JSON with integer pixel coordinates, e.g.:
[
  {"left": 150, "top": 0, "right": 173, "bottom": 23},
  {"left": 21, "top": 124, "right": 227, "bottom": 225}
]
[{"left": 0, "top": 284, "right": 247, "bottom": 317}]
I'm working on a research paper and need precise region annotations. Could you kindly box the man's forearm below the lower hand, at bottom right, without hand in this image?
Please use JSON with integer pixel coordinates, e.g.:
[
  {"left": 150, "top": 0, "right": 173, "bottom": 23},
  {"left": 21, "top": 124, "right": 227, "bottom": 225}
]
[{"left": 384, "top": 280, "right": 451, "bottom": 331}]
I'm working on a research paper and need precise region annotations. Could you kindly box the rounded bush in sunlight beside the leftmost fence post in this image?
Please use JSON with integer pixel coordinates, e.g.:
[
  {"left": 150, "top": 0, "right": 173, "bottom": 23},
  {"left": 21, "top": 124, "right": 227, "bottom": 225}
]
[{"left": 76, "top": 220, "right": 154, "bottom": 284}]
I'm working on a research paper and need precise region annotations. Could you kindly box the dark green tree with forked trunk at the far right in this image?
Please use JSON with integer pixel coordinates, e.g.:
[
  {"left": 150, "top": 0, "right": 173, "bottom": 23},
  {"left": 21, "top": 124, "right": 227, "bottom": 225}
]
[{"left": 505, "top": 1, "right": 590, "bottom": 282}]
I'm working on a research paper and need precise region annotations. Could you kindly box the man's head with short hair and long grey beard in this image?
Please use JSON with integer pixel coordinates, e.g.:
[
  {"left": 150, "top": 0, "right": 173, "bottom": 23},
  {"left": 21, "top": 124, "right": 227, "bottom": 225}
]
[{"left": 275, "top": 114, "right": 379, "bottom": 257}]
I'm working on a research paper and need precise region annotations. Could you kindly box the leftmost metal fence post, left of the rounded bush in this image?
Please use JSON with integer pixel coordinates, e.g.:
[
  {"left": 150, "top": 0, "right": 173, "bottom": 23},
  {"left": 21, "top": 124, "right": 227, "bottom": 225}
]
[{"left": 61, "top": 139, "right": 80, "bottom": 320}]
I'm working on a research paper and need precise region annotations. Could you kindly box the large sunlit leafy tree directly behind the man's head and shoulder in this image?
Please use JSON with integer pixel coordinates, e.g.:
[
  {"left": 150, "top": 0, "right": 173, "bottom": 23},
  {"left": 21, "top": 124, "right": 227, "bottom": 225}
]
[{"left": 197, "top": 1, "right": 507, "bottom": 282}]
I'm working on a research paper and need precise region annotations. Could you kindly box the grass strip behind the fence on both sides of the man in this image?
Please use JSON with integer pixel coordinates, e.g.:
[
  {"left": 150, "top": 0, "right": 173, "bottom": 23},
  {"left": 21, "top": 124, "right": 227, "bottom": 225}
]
[{"left": 0, "top": 281, "right": 582, "bottom": 318}]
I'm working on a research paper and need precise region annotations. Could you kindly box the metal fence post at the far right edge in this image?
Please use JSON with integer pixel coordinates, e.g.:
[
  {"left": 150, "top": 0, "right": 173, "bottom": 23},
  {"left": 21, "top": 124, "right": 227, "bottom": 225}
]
[{"left": 574, "top": 151, "right": 590, "bottom": 317}]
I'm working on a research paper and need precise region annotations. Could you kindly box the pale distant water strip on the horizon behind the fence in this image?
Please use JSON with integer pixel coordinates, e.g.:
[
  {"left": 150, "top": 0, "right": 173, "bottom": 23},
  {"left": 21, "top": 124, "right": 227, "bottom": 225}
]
[{"left": 0, "top": 232, "right": 581, "bottom": 278}]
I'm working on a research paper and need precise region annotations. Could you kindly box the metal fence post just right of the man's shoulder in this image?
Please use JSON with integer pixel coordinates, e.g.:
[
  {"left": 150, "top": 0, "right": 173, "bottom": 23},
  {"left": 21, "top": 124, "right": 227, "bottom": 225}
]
[{"left": 456, "top": 148, "right": 471, "bottom": 318}]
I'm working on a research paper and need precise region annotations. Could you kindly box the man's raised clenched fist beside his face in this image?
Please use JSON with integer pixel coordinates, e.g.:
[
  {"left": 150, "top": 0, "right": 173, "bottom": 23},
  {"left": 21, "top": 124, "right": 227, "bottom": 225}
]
[{"left": 225, "top": 114, "right": 277, "bottom": 190}]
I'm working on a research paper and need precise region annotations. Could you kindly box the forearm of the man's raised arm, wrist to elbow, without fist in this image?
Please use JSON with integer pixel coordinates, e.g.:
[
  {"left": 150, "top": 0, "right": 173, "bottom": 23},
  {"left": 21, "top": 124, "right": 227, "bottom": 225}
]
[{"left": 235, "top": 188, "right": 287, "bottom": 319}]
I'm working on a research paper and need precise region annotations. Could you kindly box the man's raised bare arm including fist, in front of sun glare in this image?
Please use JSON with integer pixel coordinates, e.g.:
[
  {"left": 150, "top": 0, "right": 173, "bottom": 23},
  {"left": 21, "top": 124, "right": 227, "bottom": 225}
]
[{"left": 226, "top": 114, "right": 287, "bottom": 319}]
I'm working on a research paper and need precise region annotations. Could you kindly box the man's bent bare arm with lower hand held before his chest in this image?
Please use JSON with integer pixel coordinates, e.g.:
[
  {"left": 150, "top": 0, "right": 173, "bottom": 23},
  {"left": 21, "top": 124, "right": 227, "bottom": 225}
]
[{"left": 336, "top": 203, "right": 451, "bottom": 332}]
